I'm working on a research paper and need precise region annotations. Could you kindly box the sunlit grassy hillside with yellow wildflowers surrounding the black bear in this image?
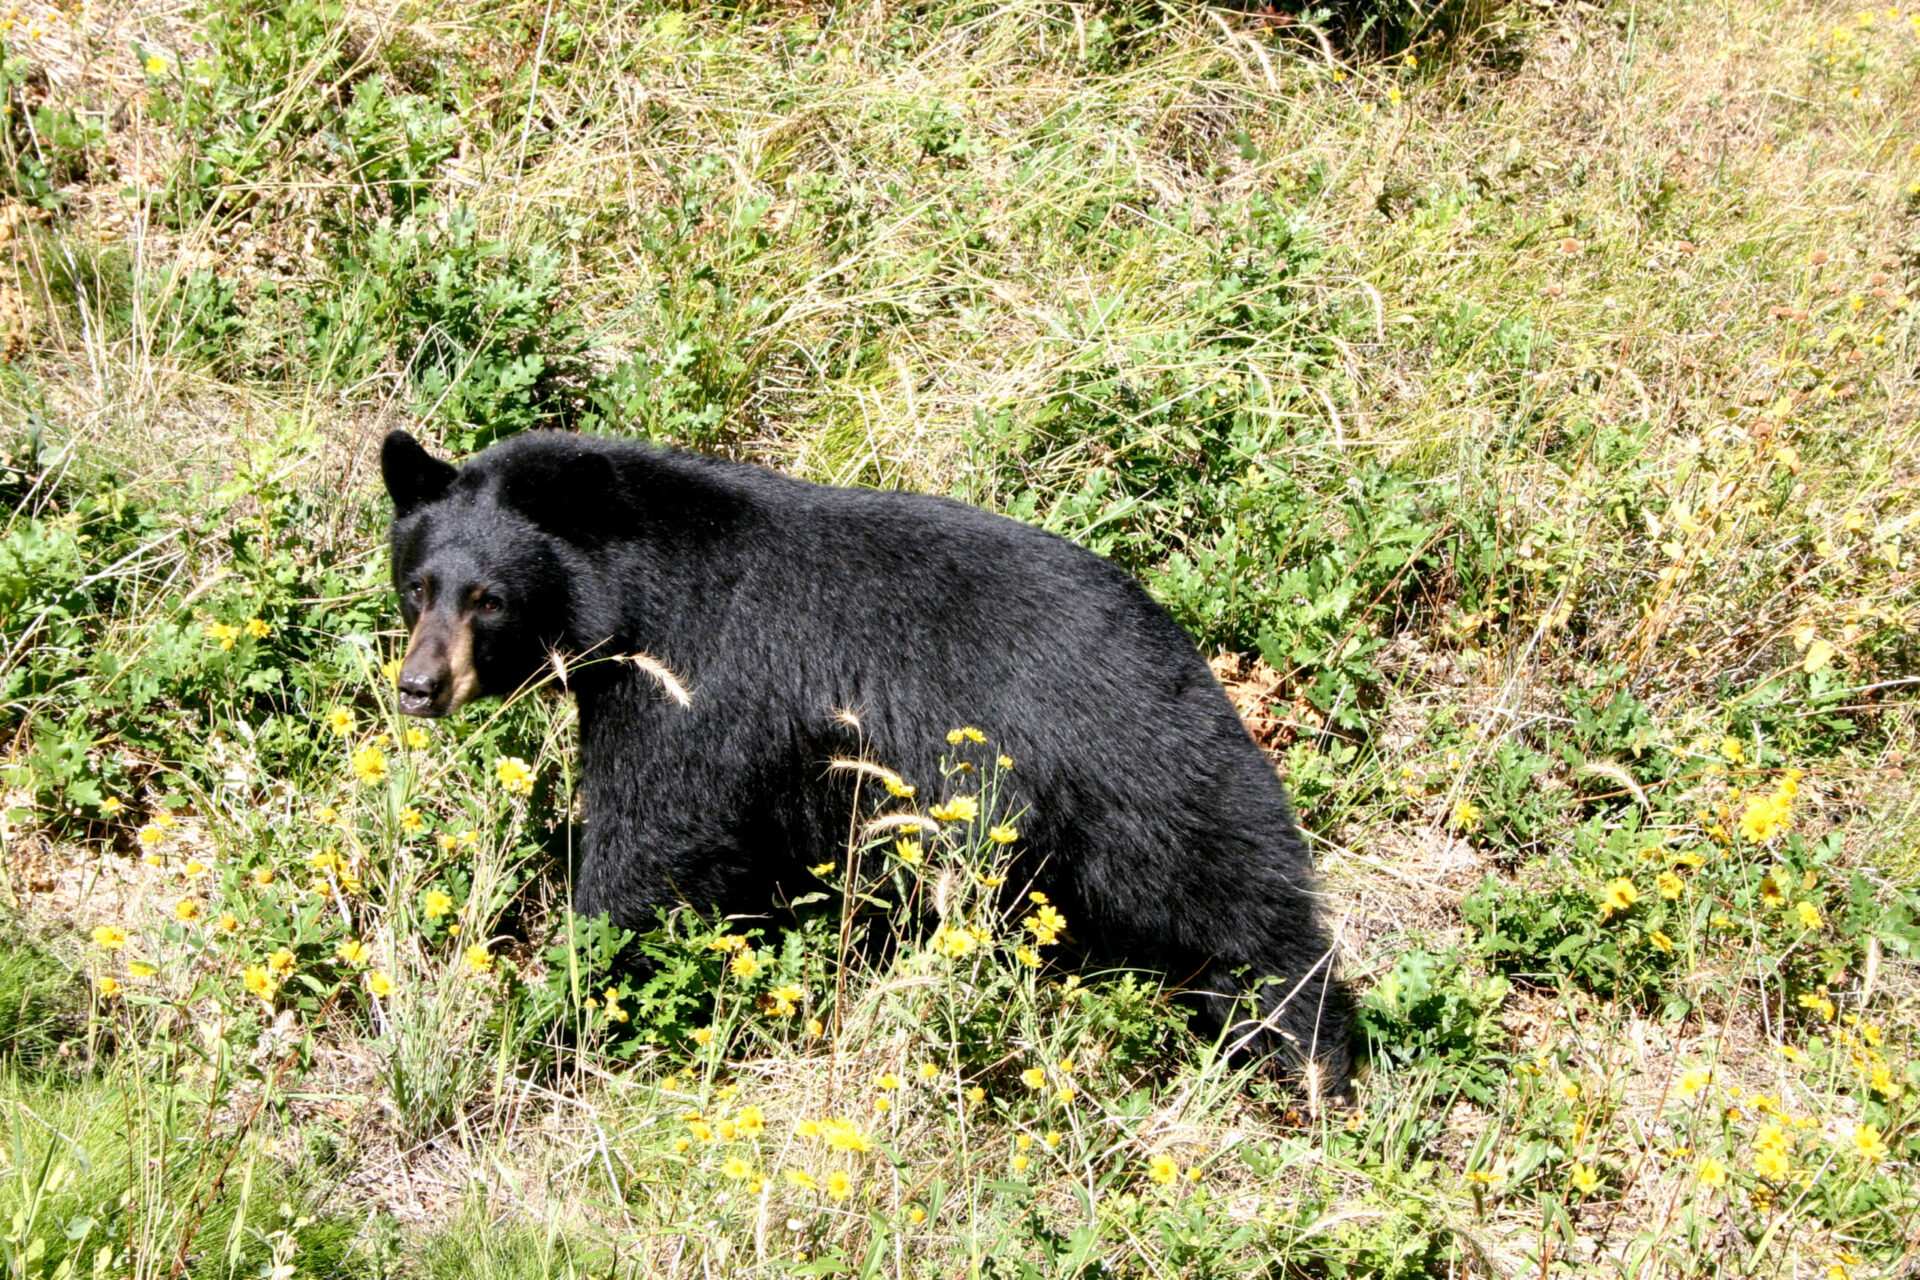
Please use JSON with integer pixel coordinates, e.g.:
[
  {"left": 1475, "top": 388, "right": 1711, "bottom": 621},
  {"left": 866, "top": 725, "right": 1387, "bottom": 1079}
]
[{"left": 0, "top": 0, "right": 1920, "bottom": 1278}]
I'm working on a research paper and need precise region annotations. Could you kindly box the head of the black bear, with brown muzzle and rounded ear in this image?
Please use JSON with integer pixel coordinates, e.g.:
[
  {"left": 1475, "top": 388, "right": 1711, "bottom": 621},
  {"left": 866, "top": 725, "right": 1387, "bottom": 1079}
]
[{"left": 380, "top": 432, "right": 570, "bottom": 716}]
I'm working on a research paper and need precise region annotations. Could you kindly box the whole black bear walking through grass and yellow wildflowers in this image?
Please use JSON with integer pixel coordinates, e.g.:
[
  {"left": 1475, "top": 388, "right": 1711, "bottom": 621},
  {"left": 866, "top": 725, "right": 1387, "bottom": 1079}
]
[{"left": 380, "top": 432, "right": 1352, "bottom": 1090}]
